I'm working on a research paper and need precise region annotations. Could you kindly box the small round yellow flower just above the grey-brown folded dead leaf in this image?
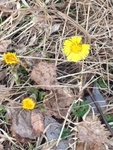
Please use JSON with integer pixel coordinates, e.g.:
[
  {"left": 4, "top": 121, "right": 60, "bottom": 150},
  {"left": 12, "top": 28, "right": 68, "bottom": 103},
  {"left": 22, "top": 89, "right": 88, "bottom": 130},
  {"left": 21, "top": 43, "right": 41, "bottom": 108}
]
[{"left": 22, "top": 97, "right": 36, "bottom": 110}]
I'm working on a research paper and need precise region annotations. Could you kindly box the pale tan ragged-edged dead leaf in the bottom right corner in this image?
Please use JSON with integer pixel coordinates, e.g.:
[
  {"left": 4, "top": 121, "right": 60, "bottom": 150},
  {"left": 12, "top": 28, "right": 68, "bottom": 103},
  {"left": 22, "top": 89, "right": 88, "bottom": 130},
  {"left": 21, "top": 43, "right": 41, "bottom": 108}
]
[{"left": 77, "top": 117, "right": 109, "bottom": 147}]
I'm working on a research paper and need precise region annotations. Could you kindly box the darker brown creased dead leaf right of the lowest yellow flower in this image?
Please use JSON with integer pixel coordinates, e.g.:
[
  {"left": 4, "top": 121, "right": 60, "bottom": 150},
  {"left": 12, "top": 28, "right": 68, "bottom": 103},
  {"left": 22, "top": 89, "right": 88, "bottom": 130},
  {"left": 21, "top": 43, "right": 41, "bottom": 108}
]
[{"left": 43, "top": 88, "right": 75, "bottom": 117}]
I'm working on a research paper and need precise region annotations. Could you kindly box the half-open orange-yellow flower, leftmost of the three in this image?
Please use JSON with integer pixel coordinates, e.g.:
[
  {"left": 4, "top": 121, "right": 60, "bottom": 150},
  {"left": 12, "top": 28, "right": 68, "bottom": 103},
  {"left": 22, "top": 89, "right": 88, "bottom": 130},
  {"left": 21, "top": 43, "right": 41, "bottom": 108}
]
[{"left": 3, "top": 52, "right": 20, "bottom": 65}]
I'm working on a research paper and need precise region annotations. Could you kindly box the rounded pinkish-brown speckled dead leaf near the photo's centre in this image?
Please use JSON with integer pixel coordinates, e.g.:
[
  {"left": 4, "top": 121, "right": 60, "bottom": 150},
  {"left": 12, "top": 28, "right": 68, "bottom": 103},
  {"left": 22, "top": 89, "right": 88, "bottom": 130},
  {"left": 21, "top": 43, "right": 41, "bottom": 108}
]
[{"left": 31, "top": 61, "right": 57, "bottom": 90}]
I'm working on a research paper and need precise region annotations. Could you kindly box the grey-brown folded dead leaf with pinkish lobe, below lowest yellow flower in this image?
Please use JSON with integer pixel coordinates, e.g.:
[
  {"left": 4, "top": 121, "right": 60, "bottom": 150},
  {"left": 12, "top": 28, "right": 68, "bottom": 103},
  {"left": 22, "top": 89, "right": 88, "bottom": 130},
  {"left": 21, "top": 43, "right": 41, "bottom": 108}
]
[{"left": 7, "top": 106, "right": 44, "bottom": 142}]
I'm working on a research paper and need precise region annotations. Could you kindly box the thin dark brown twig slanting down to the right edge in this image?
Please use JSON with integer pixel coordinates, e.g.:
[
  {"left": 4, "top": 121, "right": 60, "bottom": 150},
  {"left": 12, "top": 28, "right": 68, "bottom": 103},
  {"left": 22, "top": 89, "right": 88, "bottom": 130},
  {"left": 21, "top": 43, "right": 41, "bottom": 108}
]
[{"left": 87, "top": 89, "right": 113, "bottom": 136}]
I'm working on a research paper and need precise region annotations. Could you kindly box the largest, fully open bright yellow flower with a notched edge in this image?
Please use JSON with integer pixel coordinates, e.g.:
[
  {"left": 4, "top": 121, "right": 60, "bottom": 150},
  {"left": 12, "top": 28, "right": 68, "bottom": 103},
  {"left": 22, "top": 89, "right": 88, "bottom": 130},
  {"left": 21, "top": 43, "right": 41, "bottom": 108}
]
[{"left": 63, "top": 36, "right": 90, "bottom": 62}]
